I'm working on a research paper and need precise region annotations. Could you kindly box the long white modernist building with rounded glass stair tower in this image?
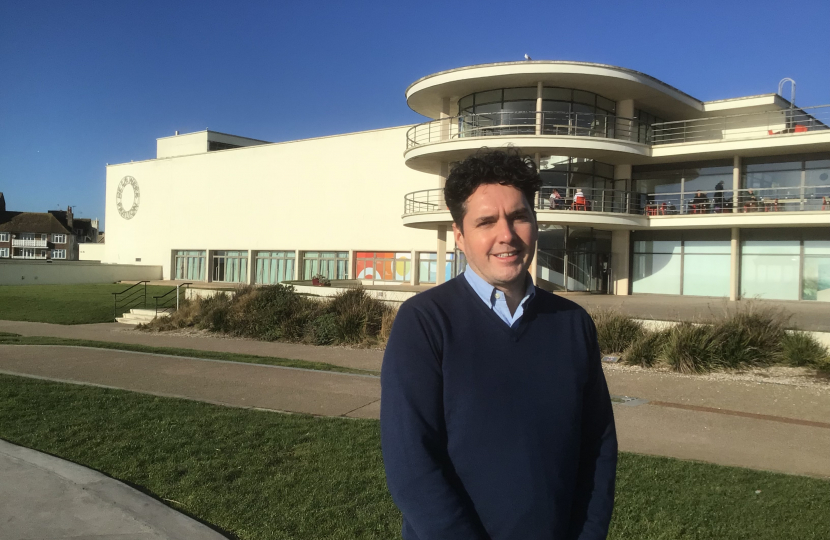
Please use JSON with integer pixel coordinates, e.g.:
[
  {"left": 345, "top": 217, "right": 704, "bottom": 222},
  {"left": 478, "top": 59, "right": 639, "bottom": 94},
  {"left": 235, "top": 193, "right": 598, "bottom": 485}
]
[{"left": 104, "top": 61, "right": 830, "bottom": 301}]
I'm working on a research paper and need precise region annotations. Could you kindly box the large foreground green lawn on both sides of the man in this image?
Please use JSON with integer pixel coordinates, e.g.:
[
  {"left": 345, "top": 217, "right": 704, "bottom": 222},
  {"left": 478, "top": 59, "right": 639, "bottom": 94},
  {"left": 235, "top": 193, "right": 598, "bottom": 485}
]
[{"left": 0, "top": 375, "right": 830, "bottom": 540}]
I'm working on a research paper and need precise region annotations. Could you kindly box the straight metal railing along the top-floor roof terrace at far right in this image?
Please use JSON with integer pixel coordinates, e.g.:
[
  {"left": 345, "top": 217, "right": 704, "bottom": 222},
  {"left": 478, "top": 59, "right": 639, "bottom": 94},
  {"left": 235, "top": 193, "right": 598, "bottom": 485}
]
[{"left": 651, "top": 105, "right": 830, "bottom": 146}]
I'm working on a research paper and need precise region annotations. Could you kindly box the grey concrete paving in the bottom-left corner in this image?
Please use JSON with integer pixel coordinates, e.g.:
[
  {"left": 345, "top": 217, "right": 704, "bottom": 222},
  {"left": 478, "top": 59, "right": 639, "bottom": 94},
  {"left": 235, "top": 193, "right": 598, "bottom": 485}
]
[{"left": 0, "top": 440, "right": 227, "bottom": 540}]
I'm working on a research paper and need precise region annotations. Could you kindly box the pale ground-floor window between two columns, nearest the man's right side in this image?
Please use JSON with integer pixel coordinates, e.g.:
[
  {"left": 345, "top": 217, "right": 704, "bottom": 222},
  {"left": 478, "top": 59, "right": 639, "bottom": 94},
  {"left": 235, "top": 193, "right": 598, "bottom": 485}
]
[{"left": 631, "top": 230, "right": 731, "bottom": 296}]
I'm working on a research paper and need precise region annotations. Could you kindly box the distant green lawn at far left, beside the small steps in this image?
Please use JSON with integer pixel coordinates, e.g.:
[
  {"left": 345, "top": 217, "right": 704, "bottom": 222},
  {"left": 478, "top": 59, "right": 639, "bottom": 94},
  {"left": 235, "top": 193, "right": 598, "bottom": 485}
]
[{"left": 0, "top": 283, "right": 178, "bottom": 324}]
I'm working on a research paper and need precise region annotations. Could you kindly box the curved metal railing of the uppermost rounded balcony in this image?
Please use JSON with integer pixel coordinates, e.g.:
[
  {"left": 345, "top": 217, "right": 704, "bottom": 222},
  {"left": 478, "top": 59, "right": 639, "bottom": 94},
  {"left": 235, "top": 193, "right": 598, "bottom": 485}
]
[{"left": 406, "top": 111, "right": 650, "bottom": 149}]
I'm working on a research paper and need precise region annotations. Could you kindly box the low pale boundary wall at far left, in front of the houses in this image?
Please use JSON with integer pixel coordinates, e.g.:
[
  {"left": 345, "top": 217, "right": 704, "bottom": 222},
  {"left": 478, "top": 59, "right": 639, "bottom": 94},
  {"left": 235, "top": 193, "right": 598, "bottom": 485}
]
[{"left": 0, "top": 259, "right": 161, "bottom": 285}]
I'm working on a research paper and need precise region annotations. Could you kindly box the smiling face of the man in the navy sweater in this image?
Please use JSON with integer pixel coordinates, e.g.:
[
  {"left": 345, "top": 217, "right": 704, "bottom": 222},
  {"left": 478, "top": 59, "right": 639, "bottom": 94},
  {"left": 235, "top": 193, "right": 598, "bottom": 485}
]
[{"left": 452, "top": 184, "right": 539, "bottom": 290}]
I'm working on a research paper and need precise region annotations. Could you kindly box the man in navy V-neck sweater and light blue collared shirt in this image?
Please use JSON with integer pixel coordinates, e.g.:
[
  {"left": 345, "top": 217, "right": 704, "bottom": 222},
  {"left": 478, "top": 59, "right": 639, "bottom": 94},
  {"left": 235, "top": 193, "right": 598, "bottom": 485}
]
[{"left": 381, "top": 150, "right": 617, "bottom": 540}]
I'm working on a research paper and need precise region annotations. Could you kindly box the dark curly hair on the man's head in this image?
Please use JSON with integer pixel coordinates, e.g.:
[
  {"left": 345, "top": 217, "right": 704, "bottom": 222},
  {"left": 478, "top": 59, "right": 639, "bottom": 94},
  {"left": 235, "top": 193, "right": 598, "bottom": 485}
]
[{"left": 444, "top": 147, "right": 542, "bottom": 230}]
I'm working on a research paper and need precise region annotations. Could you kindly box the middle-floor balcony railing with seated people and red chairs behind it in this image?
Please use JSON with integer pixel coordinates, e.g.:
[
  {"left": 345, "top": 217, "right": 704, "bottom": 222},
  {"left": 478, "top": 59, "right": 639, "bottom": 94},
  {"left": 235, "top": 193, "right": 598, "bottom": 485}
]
[{"left": 404, "top": 185, "right": 830, "bottom": 217}]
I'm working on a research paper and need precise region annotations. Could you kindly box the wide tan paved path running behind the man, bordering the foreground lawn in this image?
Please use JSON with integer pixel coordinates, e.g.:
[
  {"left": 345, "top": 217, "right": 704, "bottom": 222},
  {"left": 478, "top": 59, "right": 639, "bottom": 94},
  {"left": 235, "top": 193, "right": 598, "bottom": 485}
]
[{"left": 0, "top": 345, "right": 830, "bottom": 478}]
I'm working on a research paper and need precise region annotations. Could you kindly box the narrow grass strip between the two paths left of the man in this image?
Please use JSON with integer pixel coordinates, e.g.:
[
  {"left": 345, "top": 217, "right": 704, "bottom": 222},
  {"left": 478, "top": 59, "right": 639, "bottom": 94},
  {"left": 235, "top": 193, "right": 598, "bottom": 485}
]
[{"left": 0, "top": 332, "right": 377, "bottom": 375}]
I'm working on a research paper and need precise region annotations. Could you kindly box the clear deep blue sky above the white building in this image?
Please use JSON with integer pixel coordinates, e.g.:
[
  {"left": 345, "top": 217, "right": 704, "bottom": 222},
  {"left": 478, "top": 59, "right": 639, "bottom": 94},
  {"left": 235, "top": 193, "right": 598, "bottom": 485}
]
[{"left": 0, "top": 0, "right": 830, "bottom": 230}]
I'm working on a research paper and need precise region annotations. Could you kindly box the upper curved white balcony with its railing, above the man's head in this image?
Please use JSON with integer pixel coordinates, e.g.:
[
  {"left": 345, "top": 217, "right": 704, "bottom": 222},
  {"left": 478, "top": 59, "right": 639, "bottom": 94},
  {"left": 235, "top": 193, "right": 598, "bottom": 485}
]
[{"left": 404, "top": 111, "right": 651, "bottom": 173}]
